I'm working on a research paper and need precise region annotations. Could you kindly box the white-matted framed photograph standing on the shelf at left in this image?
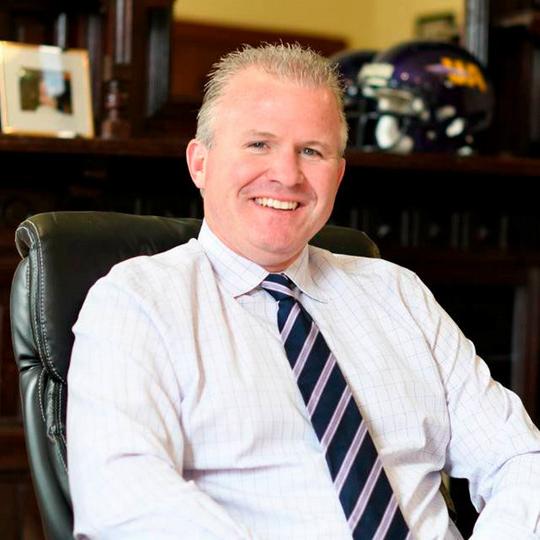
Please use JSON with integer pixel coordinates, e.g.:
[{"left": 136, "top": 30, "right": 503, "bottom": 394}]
[{"left": 0, "top": 41, "right": 94, "bottom": 137}]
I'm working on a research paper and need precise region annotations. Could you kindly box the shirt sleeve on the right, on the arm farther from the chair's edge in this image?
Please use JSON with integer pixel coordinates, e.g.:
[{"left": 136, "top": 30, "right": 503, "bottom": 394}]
[{"left": 402, "top": 278, "right": 540, "bottom": 540}]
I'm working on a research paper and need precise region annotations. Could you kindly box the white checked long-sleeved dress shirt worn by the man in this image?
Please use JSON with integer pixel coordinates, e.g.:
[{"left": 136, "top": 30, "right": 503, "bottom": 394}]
[{"left": 67, "top": 220, "right": 540, "bottom": 540}]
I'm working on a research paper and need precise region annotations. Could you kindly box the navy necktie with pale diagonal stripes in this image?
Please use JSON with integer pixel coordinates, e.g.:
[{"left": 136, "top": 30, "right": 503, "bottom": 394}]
[{"left": 261, "top": 274, "right": 411, "bottom": 540}]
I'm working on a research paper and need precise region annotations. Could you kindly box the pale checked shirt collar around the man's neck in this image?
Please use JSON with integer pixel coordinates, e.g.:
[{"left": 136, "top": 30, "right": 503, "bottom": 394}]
[{"left": 198, "top": 220, "right": 326, "bottom": 302}]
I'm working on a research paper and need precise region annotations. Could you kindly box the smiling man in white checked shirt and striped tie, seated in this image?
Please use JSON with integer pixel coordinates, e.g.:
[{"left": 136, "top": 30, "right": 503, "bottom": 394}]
[{"left": 68, "top": 45, "right": 540, "bottom": 540}]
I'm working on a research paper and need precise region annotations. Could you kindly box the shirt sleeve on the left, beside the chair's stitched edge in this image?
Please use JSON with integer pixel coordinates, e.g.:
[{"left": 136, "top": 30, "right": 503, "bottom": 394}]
[{"left": 67, "top": 272, "right": 254, "bottom": 540}]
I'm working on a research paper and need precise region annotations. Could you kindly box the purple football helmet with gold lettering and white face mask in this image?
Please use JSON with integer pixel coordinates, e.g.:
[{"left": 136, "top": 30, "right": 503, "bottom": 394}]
[{"left": 356, "top": 41, "right": 494, "bottom": 155}]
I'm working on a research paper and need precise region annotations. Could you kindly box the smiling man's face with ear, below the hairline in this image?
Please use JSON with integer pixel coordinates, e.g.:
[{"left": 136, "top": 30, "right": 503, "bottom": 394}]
[{"left": 187, "top": 68, "right": 345, "bottom": 271}]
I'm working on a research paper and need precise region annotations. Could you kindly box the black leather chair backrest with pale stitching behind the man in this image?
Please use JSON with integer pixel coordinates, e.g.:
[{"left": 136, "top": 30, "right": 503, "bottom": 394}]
[{"left": 11, "top": 212, "right": 379, "bottom": 540}]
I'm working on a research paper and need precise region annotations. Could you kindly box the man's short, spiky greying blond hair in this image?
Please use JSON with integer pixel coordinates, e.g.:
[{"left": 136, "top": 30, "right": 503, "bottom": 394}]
[{"left": 196, "top": 43, "right": 347, "bottom": 153}]
